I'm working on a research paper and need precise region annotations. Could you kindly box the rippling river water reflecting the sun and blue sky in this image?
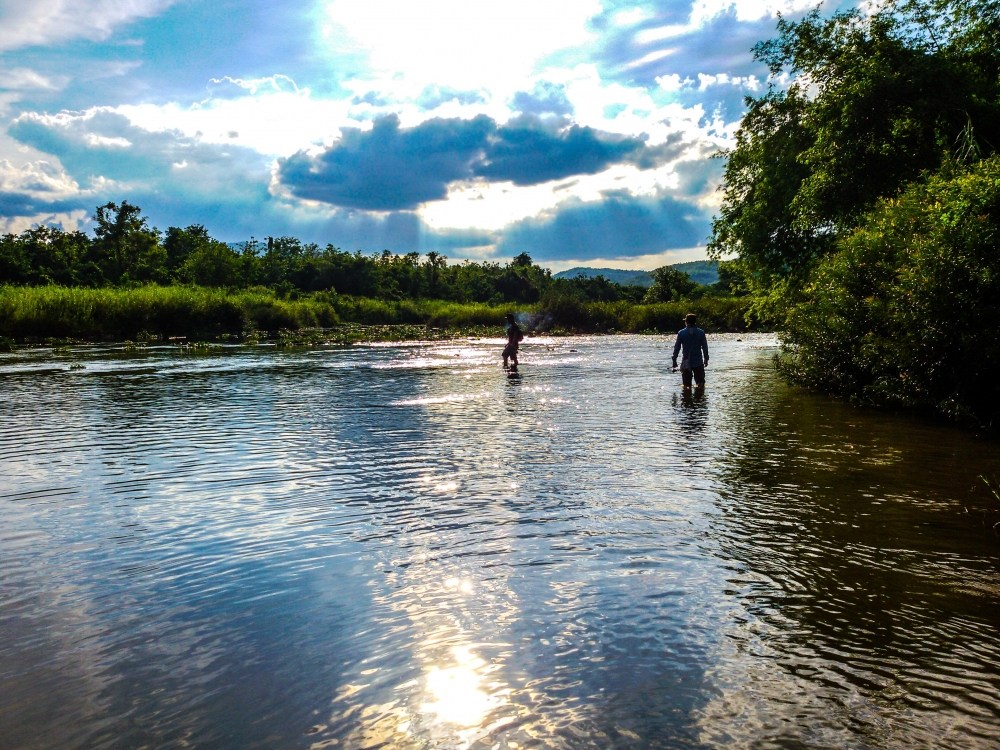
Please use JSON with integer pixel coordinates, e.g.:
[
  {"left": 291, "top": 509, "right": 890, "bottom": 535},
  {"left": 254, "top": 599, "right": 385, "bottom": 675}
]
[{"left": 0, "top": 336, "right": 1000, "bottom": 750}]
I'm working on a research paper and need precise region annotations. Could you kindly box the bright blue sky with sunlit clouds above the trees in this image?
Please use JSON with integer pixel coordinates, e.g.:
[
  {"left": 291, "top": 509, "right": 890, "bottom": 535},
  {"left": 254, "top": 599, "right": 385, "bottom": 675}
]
[{"left": 0, "top": 0, "right": 844, "bottom": 271}]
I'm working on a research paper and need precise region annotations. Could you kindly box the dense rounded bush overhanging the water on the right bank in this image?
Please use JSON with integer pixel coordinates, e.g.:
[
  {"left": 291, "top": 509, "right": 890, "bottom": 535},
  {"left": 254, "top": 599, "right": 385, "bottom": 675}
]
[{"left": 785, "top": 156, "right": 1000, "bottom": 429}]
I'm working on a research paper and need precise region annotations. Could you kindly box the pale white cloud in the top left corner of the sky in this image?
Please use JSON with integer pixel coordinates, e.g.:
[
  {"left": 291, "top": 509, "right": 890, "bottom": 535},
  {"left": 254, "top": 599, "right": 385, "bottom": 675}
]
[{"left": 0, "top": 0, "right": 175, "bottom": 52}]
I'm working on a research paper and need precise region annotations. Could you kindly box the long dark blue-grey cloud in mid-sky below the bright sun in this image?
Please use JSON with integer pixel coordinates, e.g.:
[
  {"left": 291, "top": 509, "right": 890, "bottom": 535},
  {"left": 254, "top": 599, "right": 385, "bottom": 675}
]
[{"left": 278, "top": 115, "right": 650, "bottom": 211}]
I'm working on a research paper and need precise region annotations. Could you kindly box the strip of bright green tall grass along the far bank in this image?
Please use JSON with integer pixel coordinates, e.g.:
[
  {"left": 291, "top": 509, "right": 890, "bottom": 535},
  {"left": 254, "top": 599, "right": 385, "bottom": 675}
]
[{"left": 0, "top": 285, "right": 766, "bottom": 343}]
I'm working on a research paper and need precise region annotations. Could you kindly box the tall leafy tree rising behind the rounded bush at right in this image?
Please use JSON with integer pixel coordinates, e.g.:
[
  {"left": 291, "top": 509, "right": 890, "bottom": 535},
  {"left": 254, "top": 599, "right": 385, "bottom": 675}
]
[{"left": 709, "top": 0, "right": 1000, "bottom": 286}]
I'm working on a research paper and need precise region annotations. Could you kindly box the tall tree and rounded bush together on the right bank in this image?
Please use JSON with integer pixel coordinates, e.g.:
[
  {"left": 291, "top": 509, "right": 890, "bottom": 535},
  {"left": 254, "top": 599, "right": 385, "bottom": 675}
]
[{"left": 710, "top": 0, "right": 1000, "bottom": 430}]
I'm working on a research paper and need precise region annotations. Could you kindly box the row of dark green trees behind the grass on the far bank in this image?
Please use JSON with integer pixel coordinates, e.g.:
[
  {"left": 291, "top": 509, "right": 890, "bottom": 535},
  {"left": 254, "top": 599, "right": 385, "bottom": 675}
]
[{"left": 0, "top": 201, "right": 729, "bottom": 304}]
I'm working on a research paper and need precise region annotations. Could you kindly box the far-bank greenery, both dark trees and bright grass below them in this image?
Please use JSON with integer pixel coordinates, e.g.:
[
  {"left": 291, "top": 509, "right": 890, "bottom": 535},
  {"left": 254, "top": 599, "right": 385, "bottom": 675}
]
[{"left": 0, "top": 197, "right": 750, "bottom": 346}]
